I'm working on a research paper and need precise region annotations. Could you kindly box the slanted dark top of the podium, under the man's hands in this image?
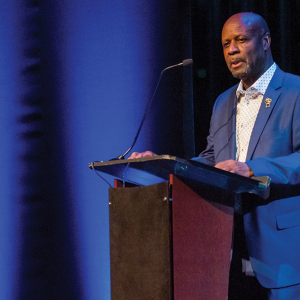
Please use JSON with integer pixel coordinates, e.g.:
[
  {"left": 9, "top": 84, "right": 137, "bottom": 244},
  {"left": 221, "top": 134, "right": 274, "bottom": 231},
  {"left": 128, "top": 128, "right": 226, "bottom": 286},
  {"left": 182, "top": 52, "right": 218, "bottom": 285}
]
[{"left": 89, "top": 155, "right": 270, "bottom": 194}]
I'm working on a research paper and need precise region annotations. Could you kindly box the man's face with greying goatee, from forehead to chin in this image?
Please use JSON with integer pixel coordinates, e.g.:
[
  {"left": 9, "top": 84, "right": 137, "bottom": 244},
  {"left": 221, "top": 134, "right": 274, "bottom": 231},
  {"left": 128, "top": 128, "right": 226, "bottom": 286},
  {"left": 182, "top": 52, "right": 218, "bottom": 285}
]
[{"left": 222, "top": 18, "right": 267, "bottom": 84}]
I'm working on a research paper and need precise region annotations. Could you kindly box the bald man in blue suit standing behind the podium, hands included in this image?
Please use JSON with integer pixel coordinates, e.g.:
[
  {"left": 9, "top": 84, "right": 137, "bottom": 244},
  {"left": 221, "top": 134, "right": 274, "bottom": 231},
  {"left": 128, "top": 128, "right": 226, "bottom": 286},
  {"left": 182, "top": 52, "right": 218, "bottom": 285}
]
[{"left": 130, "top": 13, "right": 300, "bottom": 300}]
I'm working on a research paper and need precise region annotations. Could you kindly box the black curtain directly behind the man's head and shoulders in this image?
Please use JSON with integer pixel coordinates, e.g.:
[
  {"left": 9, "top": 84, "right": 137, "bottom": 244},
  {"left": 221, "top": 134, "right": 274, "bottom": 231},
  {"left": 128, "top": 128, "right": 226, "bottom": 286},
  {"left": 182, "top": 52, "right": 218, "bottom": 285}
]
[{"left": 192, "top": 0, "right": 300, "bottom": 155}]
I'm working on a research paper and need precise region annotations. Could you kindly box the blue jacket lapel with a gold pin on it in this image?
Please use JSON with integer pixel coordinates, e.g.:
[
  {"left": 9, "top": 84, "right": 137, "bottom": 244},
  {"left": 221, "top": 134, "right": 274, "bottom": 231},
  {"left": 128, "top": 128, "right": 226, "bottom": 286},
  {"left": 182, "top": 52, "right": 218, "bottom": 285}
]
[{"left": 246, "top": 67, "right": 285, "bottom": 160}]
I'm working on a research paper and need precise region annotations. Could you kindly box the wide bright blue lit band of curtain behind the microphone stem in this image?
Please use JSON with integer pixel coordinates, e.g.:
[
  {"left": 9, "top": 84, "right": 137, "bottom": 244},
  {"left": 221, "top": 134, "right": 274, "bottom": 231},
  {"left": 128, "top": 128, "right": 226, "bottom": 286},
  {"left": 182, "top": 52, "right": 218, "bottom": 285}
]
[{"left": 53, "top": 0, "right": 159, "bottom": 300}]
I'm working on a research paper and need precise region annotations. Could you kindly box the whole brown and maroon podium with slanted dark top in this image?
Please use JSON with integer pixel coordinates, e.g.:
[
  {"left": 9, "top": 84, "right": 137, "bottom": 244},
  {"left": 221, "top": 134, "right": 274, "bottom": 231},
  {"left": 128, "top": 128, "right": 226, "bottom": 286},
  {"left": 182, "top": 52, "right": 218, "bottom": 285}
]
[{"left": 89, "top": 155, "right": 269, "bottom": 300}]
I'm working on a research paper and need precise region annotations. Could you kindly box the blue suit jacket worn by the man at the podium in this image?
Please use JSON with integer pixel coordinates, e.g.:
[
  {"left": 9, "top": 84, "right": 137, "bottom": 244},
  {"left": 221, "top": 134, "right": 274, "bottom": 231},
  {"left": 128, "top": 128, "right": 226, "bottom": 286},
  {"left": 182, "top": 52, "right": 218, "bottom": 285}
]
[{"left": 195, "top": 67, "right": 300, "bottom": 288}]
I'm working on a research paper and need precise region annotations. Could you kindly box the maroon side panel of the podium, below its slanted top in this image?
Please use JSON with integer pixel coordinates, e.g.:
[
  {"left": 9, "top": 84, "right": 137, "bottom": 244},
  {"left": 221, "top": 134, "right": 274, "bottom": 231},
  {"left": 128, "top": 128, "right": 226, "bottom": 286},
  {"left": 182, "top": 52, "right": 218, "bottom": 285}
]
[{"left": 170, "top": 175, "right": 233, "bottom": 300}]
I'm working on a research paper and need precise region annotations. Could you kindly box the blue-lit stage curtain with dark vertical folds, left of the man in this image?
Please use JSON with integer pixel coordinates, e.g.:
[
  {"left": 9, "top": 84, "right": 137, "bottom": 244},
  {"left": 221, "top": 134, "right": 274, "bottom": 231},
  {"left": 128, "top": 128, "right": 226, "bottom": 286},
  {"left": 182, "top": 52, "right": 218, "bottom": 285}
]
[{"left": 0, "top": 0, "right": 194, "bottom": 300}]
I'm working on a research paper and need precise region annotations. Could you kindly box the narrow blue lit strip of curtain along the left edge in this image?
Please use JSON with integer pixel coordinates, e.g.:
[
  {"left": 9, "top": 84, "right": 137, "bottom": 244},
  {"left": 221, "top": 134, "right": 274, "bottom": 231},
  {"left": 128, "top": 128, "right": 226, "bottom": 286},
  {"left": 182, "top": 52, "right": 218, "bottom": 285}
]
[{"left": 0, "top": 0, "right": 20, "bottom": 299}]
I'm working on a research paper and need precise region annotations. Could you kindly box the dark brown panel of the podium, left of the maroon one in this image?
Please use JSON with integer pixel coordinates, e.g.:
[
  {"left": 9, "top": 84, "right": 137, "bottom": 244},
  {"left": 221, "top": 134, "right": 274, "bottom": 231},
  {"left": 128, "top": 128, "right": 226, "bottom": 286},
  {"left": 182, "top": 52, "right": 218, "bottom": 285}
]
[{"left": 109, "top": 182, "right": 173, "bottom": 300}]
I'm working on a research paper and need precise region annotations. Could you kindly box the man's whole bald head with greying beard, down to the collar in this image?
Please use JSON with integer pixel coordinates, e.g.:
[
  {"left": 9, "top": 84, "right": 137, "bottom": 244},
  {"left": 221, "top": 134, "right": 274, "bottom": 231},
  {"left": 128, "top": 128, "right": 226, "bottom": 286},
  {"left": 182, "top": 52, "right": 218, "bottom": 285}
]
[{"left": 222, "top": 12, "right": 273, "bottom": 88}]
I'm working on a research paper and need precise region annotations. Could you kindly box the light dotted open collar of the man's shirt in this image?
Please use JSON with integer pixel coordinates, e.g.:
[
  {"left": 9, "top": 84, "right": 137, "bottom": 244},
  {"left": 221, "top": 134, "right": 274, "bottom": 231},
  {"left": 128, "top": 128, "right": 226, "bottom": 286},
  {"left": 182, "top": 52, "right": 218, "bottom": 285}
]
[{"left": 236, "top": 62, "right": 277, "bottom": 98}]
